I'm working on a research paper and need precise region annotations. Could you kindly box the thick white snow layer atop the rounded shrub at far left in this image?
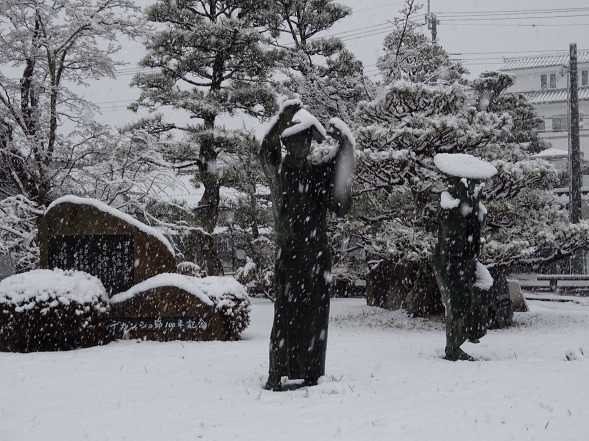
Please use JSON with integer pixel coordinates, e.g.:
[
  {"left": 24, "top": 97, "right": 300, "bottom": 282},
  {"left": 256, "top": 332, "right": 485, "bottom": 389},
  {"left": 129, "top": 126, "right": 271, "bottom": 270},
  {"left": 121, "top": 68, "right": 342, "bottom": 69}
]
[{"left": 0, "top": 269, "right": 108, "bottom": 312}]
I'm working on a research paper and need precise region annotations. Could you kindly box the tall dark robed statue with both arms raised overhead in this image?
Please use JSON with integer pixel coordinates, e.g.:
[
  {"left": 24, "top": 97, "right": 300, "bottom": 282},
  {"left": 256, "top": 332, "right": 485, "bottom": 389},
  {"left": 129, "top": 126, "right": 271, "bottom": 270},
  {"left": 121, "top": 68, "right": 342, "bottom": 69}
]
[{"left": 260, "top": 100, "right": 354, "bottom": 391}]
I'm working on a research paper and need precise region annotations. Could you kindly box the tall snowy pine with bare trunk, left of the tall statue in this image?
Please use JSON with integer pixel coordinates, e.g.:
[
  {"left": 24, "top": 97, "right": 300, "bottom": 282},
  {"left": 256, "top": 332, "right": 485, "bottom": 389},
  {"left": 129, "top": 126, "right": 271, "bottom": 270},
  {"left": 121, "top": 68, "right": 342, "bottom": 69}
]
[{"left": 132, "top": 0, "right": 276, "bottom": 273}]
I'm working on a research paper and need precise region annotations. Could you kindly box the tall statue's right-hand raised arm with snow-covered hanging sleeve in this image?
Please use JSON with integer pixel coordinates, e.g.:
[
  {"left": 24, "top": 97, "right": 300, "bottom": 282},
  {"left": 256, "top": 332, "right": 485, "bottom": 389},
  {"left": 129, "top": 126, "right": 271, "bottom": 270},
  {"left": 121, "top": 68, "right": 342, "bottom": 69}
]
[{"left": 329, "top": 118, "right": 355, "bottom": 216}]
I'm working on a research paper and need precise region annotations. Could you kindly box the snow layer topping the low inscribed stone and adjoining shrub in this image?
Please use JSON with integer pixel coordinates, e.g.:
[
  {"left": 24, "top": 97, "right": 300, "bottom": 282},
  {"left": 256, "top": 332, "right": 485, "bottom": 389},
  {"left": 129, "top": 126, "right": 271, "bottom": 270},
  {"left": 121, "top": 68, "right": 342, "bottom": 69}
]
[{"left": 110, "top": 273, "right": 248, "bottom": 308}]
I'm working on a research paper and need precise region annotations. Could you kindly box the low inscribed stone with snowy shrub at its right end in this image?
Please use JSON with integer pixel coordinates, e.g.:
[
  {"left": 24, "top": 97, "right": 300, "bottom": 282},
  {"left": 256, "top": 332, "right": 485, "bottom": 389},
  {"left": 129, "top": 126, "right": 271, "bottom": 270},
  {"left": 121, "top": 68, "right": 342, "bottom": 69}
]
[{"left": 108, "top": 274, "right": 250, "bottom": 341}]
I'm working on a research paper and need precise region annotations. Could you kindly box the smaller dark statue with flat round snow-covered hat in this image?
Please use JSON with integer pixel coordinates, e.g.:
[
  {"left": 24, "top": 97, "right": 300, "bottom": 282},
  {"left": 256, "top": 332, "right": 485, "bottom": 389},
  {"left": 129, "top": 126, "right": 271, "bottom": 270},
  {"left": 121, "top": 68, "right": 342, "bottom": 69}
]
[{"left": 434, "top": 153, "right": 497, "bottom": 361}]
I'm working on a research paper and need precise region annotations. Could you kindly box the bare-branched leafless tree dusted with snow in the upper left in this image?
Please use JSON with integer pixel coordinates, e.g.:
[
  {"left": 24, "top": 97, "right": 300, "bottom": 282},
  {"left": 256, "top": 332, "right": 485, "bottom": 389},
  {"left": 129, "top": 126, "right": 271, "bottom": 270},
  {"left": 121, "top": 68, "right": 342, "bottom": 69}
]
[{"left": 0, "top": 0, "right": 142, "bottom": 205}]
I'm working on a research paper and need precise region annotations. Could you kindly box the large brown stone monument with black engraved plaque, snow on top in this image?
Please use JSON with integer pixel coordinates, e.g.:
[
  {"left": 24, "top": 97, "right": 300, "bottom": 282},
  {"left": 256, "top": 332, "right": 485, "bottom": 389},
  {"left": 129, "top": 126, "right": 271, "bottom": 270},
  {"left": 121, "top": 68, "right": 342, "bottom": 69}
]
[{"left": 38, "top": 196, "right": 176, "bottom": 296}]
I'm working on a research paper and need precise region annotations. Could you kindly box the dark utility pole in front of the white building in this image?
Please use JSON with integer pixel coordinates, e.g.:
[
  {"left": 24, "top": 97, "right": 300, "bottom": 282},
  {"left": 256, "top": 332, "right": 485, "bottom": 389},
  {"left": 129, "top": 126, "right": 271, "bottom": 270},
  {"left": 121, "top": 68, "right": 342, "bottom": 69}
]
[{"left": 569, "top": 43, "right": 585, "bottom": 274}]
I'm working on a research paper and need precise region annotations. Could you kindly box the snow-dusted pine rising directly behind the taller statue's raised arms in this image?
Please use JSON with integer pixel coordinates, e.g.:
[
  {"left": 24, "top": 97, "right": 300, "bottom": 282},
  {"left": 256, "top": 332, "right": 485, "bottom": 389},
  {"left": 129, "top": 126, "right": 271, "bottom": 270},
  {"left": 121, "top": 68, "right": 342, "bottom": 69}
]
[{"left": 260, "top": 0, "right": 374, "bottom": 124}]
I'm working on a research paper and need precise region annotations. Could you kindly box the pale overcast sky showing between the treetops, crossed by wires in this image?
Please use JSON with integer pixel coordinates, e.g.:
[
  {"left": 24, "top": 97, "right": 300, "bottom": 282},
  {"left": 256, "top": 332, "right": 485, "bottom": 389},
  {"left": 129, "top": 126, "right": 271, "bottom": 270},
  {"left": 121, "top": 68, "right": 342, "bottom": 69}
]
[{"left": 86, "top": 0, "right": 589, "bottom": 128}]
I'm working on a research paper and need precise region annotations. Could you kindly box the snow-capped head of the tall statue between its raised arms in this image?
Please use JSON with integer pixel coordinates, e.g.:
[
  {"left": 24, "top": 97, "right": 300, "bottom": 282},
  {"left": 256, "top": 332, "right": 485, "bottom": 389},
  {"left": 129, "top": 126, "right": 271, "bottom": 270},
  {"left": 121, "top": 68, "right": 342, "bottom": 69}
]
[{"left": 280, "top": 109, "right": 327, "bottom": 158}]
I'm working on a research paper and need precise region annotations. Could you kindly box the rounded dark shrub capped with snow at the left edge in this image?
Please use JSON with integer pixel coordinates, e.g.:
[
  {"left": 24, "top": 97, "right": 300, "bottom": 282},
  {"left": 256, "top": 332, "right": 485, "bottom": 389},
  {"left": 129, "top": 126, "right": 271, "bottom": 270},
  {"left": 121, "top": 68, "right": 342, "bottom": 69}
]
[{"left": 0, "top": 269, "right": 109, "bottom": 352}]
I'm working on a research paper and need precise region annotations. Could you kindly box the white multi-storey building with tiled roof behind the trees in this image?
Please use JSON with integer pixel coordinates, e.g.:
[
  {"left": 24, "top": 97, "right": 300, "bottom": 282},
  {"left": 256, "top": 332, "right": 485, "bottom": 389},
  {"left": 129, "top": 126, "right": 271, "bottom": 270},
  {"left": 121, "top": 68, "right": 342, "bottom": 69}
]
[{"left": 500, "top": 50, "right": 589, "bottom": 158}]
